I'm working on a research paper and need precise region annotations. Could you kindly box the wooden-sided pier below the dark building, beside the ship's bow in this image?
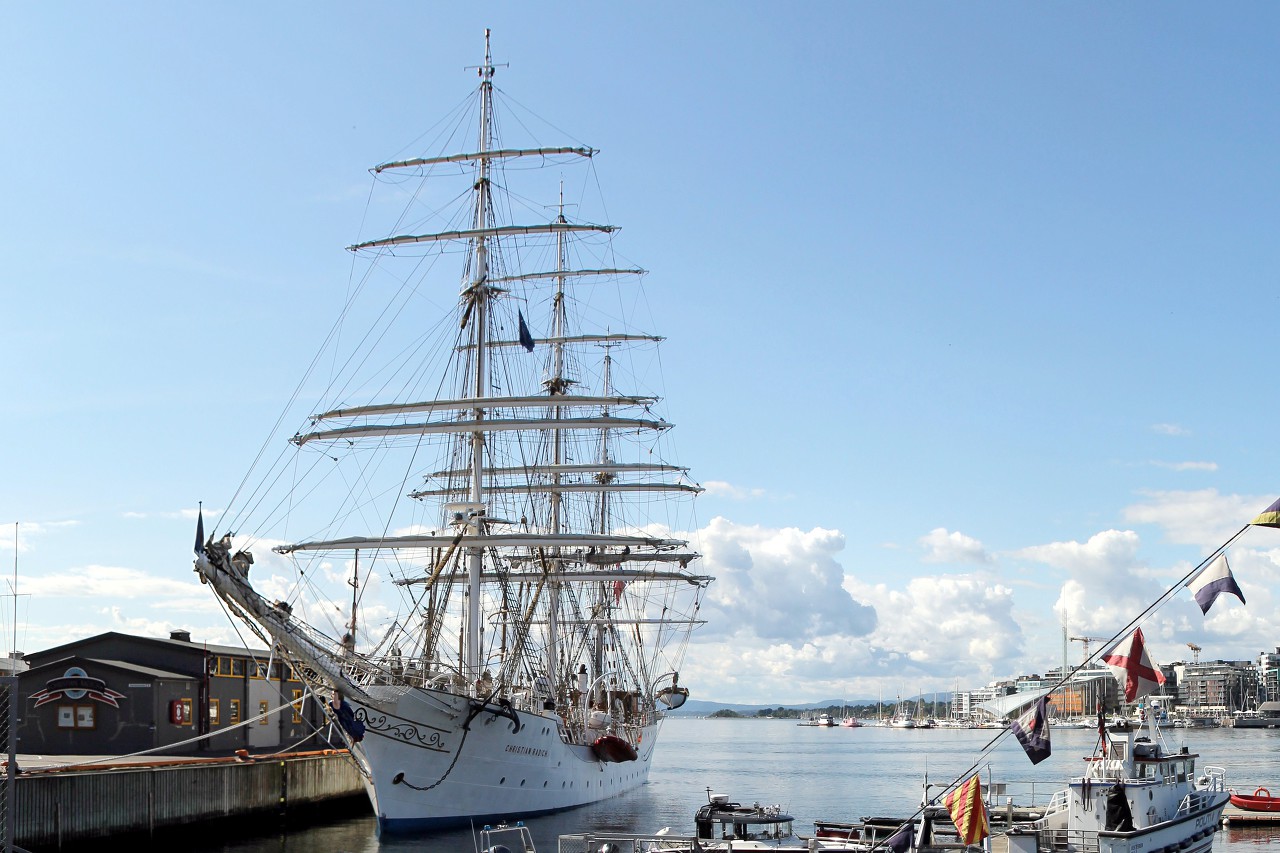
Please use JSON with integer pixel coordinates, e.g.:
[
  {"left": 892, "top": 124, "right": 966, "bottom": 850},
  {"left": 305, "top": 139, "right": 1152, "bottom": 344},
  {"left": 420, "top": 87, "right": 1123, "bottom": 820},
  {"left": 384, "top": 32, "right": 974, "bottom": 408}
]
[{"left": 13, "top": 749, "right": 367, "bottom": 850}]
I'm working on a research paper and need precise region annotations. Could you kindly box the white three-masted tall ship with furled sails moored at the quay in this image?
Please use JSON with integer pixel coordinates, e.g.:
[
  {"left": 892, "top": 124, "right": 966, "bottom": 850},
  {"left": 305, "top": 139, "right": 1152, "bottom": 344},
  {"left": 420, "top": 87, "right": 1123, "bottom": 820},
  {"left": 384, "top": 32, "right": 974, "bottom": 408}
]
[{"left": 196, "top": 31, "right": 712, "bottom": 829}]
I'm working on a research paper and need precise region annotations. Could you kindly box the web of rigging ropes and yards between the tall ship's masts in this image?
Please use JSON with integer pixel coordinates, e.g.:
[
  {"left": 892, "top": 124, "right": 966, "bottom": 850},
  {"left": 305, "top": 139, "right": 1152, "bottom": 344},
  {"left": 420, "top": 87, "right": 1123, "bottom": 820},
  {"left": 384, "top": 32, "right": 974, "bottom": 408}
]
[{"left": 199, "top": 89, "right": 705, "bottom": 706}]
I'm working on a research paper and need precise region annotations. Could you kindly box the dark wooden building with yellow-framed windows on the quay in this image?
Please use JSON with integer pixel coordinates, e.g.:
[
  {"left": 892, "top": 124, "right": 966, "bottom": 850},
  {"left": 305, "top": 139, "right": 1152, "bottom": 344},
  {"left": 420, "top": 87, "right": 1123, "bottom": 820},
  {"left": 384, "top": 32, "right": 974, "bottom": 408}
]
[{"left": 18, "top": 631, "right": 332, "bottom": 756}]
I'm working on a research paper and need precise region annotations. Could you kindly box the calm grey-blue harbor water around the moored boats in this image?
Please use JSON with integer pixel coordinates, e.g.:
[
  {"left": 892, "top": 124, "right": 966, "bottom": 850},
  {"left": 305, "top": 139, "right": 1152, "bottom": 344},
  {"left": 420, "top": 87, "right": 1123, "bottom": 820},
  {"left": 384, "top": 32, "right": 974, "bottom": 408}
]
[{"left": 184, "top": 719, "right": 1280, "bottom": 853}]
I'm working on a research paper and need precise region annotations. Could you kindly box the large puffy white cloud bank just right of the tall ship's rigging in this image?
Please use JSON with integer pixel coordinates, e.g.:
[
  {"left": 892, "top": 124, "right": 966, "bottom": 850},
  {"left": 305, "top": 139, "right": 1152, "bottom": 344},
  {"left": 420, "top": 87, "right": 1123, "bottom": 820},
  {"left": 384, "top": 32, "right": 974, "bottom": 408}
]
[{"left": 681, "top": 519, "right": 1023, "bottom": 701}]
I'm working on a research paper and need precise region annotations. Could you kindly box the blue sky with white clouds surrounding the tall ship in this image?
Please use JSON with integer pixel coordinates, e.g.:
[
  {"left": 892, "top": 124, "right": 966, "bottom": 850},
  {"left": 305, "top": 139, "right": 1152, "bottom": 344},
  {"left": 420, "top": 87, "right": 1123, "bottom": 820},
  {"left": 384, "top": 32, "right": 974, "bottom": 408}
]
[{"left": 0, "top": 3, "right": 1280, "bottom": 702}]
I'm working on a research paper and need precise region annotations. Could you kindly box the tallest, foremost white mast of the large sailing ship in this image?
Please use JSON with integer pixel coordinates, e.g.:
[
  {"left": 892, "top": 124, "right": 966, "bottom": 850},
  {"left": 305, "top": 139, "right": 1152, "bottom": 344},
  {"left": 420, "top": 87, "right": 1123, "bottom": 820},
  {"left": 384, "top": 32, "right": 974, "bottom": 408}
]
[{"left": 463, "top": 29, "right": 494, "bottom": 684}]
